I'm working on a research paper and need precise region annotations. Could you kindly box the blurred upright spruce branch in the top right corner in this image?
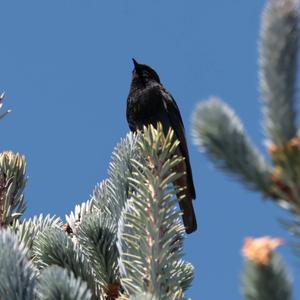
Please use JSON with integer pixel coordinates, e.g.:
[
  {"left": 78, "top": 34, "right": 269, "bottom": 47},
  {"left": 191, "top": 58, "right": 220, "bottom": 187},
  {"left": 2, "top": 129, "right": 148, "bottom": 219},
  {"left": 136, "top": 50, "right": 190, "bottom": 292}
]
[{"left": 260, "top": 0, "right": 300, "bottom": 209}]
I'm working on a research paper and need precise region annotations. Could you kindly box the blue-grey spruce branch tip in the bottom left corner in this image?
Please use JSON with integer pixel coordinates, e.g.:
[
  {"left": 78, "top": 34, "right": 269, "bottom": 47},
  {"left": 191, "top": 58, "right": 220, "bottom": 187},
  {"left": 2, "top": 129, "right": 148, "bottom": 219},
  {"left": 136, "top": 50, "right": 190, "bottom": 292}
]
[{"left": 0, "top": 230, "right": 36, "bottom": 300}]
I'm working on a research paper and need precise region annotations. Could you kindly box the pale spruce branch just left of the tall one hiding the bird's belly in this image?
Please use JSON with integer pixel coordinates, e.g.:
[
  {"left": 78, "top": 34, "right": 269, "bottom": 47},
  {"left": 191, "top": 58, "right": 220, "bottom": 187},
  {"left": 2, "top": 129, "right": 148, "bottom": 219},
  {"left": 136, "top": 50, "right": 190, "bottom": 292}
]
[{"left": 54, "top": 133, "right": 143, "bottom": 299}]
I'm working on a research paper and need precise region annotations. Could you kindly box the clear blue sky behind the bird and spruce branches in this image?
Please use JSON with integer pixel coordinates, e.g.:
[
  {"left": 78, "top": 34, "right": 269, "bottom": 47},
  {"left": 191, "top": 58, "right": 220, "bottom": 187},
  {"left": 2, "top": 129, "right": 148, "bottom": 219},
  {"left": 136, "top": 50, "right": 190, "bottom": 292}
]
[{"left": 0, "top": 0, "right": 300, "bottom": 300}]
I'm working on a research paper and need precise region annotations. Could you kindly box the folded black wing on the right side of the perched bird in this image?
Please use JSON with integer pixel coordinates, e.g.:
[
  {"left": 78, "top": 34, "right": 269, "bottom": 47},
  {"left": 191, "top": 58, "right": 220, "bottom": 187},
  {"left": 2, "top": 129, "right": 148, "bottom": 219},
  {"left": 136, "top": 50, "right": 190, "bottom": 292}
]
[{"left": 161, "top": 89, "right": 196, "bottom": 199}]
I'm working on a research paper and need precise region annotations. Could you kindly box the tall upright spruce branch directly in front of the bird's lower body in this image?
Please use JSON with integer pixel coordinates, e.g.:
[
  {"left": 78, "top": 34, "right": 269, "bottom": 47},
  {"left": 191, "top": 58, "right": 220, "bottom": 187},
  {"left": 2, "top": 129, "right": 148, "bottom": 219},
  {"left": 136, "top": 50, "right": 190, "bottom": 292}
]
[{"left": 118, "top": 124, "right": 193, "bottom": 300}]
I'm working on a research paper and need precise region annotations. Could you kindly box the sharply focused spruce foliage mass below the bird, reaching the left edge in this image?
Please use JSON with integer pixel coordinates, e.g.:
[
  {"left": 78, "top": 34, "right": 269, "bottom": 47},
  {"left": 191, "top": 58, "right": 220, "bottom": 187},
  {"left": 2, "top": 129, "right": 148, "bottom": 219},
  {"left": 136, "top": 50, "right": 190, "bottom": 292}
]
[{"left": 0, "top": 120, "right": 193, "bottom": 300}]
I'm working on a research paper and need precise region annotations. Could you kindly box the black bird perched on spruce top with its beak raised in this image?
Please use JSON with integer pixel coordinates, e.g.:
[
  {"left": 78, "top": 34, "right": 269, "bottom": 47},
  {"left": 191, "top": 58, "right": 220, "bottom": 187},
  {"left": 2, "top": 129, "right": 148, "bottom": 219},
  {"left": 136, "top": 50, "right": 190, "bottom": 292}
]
[{"left": 126, "top": 59, "right": 197, "bottom": 233}]
